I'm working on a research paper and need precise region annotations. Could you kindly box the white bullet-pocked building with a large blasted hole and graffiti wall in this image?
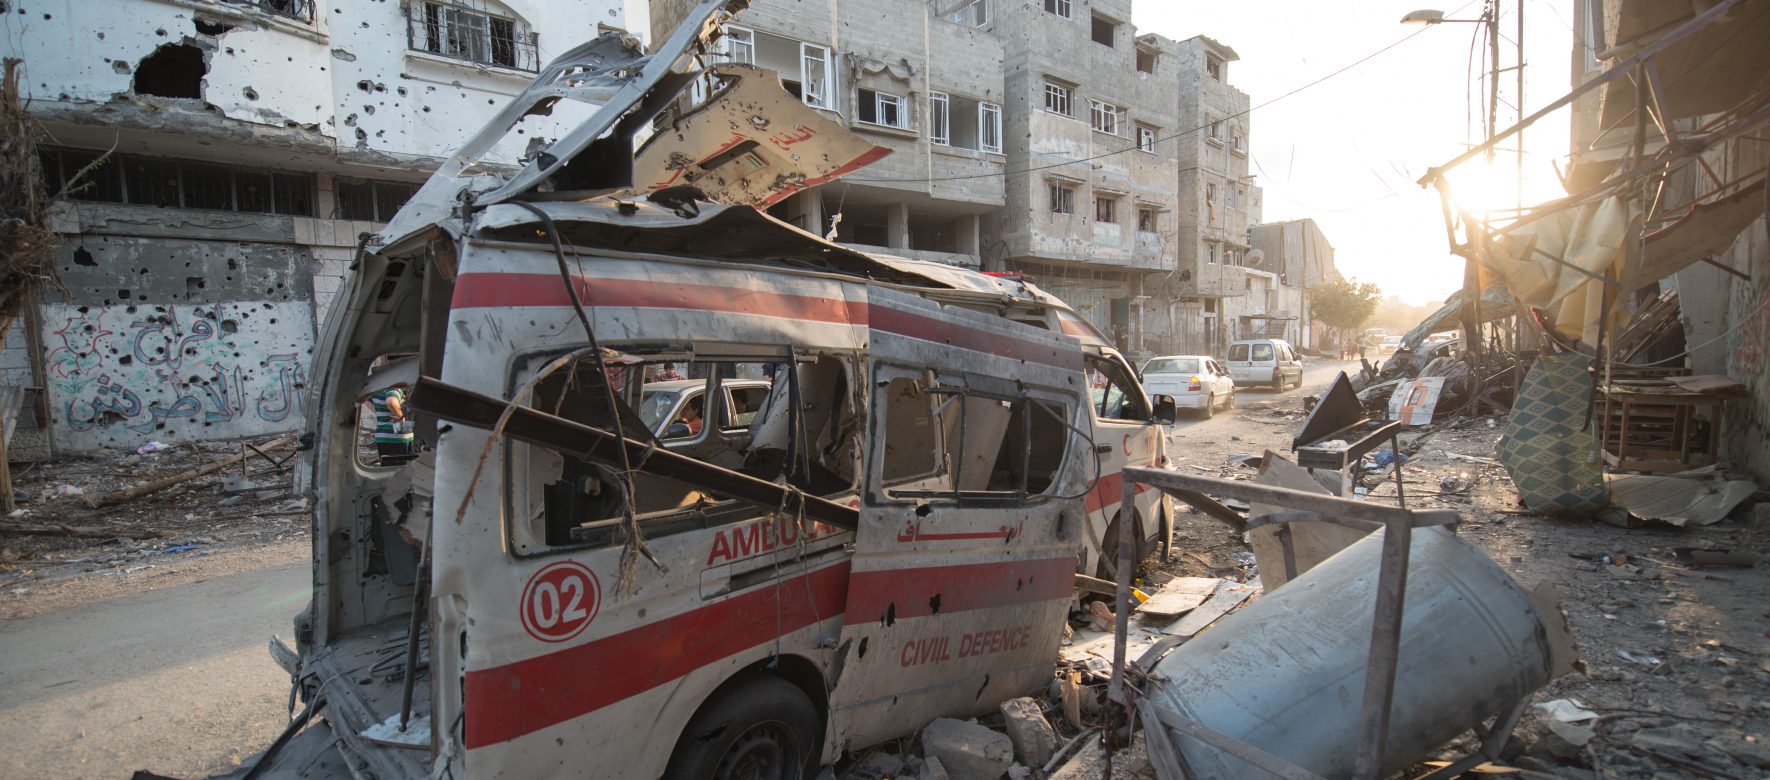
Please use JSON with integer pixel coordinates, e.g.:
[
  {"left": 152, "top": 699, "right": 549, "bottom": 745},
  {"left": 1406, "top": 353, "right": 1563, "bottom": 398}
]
[{"left": 0, "top": 0, "right": 625, "bottom": 458}]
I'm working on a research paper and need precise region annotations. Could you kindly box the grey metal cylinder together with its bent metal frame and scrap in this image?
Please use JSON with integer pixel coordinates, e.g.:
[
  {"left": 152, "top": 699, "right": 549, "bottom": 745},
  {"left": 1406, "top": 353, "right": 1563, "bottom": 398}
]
[{"left": 1108, "top": 463, "right": 1577, "bottom": 780}]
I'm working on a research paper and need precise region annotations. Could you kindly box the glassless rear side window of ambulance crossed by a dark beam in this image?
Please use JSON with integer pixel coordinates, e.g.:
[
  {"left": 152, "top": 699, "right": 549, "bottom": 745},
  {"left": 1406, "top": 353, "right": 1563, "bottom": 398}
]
[{"left": 508, "top": 350, "right": 858, "bottom": 554}]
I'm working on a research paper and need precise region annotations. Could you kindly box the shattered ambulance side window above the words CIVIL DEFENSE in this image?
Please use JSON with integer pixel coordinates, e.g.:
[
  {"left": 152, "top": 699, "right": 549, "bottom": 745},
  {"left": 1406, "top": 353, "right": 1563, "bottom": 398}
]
[{"left": 873, "top": 366, "right": 1069, "bottom": 502}]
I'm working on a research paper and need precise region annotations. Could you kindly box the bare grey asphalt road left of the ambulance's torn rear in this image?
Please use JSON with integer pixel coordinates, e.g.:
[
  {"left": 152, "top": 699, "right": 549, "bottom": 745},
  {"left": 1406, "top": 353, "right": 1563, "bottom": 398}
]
[{"left": 0, "top": 559, "right": 312, "bottom": 778}]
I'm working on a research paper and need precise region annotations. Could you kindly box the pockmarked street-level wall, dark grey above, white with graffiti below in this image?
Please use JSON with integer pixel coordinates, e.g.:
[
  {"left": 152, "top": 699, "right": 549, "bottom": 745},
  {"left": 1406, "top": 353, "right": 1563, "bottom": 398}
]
[{"left": 41, "top": 205, "right": 313, "bottom": 453}]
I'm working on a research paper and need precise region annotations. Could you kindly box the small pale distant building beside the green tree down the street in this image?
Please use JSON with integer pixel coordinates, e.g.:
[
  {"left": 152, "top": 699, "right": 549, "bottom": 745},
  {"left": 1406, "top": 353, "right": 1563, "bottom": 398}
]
[{"left": 1235, "top": 219, "right": 1340, "bottom": 348}]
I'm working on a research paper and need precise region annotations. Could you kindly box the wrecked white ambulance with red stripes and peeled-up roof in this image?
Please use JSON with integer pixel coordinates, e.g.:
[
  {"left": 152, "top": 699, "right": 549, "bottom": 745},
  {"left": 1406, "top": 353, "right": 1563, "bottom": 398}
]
[{"left": 248, "top": 2, "right": 1174, "bottom": 778}]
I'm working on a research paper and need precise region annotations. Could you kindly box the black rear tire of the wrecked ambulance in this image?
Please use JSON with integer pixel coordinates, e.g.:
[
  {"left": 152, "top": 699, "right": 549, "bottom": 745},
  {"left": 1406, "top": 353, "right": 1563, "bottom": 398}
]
[{"left": 664, "top": 677, "right": 823, "bottom": 780}]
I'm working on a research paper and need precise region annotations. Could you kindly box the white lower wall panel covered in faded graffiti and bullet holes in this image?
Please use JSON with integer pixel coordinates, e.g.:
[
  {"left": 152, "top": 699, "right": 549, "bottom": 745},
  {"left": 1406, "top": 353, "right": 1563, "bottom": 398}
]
[{"left": 44, "top": 302, "right": 313, "bottom": 451}]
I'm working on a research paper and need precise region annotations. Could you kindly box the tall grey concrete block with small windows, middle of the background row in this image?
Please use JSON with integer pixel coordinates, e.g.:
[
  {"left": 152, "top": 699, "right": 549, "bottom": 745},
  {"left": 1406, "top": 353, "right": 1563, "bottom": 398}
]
[{"left": 991, "top": 0, "right": 1186, "bottom": 352}]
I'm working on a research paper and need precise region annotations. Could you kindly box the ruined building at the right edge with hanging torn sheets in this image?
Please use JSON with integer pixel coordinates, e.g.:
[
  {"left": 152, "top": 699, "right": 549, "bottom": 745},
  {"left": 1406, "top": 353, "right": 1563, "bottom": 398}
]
[{"left": 1564, "top": 0, "right": 1770, "bottom": 479}]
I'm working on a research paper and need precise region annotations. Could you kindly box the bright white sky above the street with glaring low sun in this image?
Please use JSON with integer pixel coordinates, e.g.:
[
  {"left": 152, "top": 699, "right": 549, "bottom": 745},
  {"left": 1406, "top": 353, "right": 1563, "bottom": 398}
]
[{"left": 1133, "top": 0, "right": 1574, "bottom": 304}]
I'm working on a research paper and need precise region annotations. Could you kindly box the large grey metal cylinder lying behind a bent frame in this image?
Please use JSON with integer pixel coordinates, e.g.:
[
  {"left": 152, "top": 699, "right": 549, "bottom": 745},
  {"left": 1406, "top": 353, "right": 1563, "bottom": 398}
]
[{"left": 1145, "top": 527, "right": 1551, "bottom": 780}]
